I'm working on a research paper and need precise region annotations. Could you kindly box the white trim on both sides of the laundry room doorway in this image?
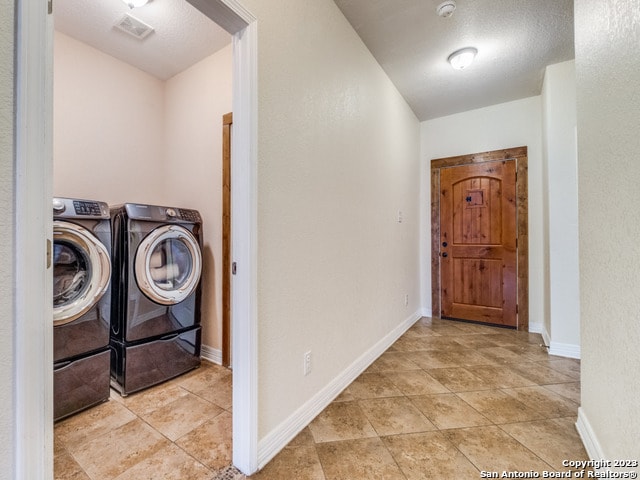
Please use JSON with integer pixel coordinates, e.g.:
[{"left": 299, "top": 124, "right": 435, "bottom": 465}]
[{"left": 13, "top": 0, "right": 258, "bottom": 480}]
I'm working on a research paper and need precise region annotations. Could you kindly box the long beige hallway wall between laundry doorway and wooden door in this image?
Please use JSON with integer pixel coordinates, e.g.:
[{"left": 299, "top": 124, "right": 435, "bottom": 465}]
[{"left": 242, "top": 0, "right": 419, "bottom": 439}]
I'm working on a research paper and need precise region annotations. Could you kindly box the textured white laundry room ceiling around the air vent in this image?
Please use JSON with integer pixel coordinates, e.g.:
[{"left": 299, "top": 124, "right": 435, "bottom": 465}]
[{"left": 54, "top": 0, "right": 231, "bottom": 80}]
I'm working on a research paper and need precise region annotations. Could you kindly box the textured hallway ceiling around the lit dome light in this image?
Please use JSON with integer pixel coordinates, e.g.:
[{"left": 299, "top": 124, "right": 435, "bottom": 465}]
[{"left": 335, "top": 0, "right": 574, "bottom": 120}]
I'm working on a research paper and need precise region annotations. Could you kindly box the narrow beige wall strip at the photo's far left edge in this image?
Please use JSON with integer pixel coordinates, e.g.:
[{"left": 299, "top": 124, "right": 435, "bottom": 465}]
[{"left": 0, "top": 0, "right": 16, "bottom": 472}]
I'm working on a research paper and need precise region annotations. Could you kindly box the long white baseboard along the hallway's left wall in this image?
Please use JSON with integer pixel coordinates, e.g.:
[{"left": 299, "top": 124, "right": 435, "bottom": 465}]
[{"left": 258, "top": 311, "right": 423, "bottom": 469}]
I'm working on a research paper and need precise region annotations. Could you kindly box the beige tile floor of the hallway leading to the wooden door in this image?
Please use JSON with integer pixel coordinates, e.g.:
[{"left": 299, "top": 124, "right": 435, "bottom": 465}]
[{"left": 251, "top": 318, "right": 588, "bottom": 480}]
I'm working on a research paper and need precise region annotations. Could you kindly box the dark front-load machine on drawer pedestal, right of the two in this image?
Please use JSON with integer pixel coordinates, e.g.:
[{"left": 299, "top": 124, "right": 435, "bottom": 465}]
[{"left": 111, "top": 203, "right": 202, "bottom": 396}]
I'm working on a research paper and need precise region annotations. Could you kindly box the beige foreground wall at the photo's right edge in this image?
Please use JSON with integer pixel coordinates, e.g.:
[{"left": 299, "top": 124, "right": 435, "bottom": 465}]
[{"left": 575, "top": 0, "right": 640, "bottom": 460}]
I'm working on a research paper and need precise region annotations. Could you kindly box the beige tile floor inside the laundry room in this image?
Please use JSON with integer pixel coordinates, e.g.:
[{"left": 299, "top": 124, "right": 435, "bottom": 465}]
[{"left": 54, "top": 361, "right": 235, "bottom": 480}]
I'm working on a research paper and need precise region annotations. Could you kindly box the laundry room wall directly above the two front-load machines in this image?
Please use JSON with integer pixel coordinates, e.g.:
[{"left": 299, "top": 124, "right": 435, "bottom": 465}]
[{"left": 53, "top": 32, "right": 164, "bottom": 205}]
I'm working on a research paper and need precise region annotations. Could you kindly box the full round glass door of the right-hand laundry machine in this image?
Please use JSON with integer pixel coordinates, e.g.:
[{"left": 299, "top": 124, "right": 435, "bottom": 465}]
[{"left": 135, "top": 225, "right": 202, "bottom": 305}]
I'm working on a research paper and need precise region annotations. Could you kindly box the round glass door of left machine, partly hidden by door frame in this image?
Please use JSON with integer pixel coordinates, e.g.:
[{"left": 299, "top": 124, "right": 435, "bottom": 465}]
[{"left": 53, "top": 220, "right": 111, "bottom": 326}]
